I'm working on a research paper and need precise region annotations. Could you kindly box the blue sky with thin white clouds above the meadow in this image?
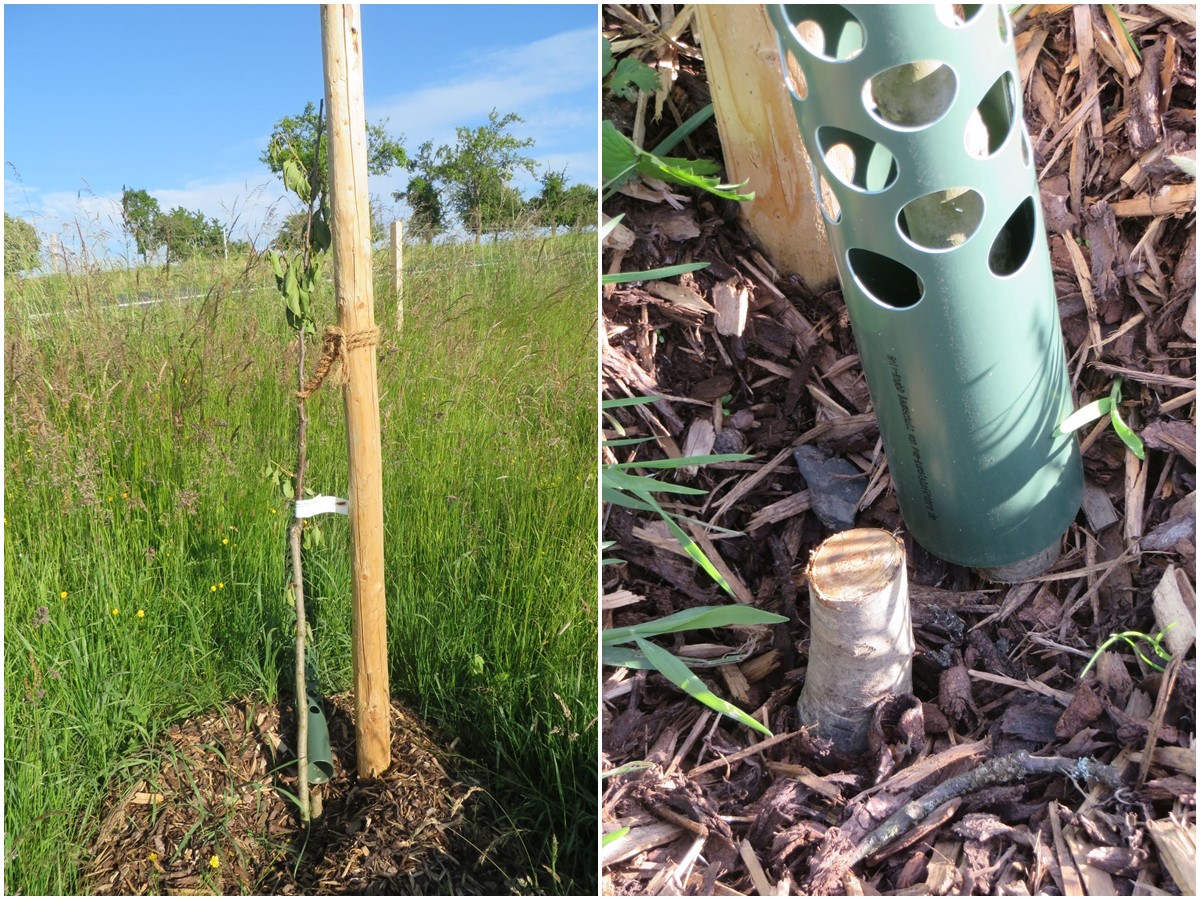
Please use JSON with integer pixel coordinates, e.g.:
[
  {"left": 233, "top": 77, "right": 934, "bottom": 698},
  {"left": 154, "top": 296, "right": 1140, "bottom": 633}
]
[{"left": 4, "top": 4, "right": 600, "bottom": 258}]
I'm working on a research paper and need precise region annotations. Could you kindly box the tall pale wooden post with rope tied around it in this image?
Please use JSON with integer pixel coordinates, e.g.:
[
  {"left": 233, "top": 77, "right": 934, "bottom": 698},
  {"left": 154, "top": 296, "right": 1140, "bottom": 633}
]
[{"left": 320, "top": 4, "right": 391, "bottom": 778}]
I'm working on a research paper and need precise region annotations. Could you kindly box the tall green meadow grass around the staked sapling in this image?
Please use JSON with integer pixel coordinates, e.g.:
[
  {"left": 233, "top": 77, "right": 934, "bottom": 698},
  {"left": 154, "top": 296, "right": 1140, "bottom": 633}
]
[{"left": 4, "top": 235, "right": 596, "bottom": 894}]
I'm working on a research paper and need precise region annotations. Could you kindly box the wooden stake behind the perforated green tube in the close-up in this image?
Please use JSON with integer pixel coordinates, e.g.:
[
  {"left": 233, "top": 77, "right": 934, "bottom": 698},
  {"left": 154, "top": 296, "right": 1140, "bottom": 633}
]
[{"left": 695, "top": 4, "right": 838, "bottom": 290}]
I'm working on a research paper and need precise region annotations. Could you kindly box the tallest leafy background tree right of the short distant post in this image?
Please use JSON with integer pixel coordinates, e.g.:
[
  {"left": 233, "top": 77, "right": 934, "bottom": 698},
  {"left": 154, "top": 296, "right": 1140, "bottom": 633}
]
[{"left": 436, "top": 109, "right": 538, "bottom": 244}]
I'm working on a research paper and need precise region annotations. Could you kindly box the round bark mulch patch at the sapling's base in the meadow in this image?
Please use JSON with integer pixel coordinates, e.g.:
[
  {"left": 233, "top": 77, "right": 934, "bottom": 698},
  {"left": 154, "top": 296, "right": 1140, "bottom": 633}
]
[{"left": 86, "top": 694, "right": 528, "bottom": 895}]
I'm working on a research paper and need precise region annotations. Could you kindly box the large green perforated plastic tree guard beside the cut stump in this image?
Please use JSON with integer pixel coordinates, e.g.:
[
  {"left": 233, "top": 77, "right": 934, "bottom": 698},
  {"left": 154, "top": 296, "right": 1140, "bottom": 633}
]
[{"left": 768, "top": 4, "right": 1084, "bottom": 581}]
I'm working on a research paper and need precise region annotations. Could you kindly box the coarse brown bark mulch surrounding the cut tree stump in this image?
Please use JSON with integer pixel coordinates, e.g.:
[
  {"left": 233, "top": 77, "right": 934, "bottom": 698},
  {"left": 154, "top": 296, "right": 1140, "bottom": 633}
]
[{"left": 601, "top": 6, "right": 1196, "bottom": 895}]
